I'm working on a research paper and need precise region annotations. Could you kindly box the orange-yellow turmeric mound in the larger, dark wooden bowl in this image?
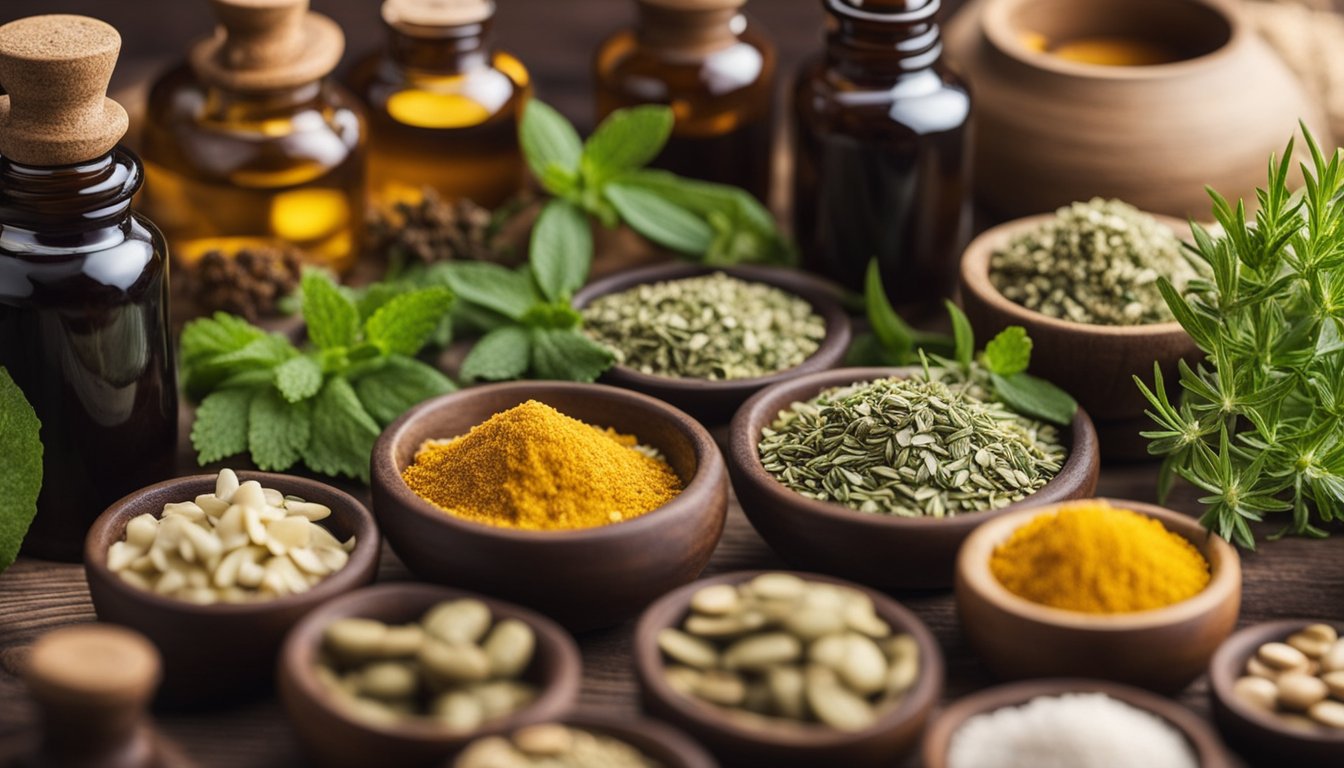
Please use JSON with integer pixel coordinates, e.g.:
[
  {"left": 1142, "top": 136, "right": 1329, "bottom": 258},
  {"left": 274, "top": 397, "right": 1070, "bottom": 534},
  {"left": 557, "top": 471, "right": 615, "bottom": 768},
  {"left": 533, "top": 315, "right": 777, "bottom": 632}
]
[{"left": 402, "top": 399, "right": 681, "bottom": 530}]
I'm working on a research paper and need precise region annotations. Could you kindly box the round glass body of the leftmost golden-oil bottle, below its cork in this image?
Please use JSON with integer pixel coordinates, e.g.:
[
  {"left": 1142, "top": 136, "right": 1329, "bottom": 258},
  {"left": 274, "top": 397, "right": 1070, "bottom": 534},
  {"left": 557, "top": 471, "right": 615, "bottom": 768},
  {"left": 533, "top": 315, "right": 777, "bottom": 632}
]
[{"left": 142, "top": 67, "right": 364, "bottom": 272}]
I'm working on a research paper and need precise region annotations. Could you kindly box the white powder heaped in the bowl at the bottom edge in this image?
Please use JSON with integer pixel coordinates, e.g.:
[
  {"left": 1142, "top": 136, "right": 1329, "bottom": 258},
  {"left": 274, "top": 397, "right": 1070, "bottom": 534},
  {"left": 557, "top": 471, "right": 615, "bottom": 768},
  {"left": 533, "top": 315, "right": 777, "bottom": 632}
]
[{"left": 948, "top": 693, "right": 1199, "bottom": 768}]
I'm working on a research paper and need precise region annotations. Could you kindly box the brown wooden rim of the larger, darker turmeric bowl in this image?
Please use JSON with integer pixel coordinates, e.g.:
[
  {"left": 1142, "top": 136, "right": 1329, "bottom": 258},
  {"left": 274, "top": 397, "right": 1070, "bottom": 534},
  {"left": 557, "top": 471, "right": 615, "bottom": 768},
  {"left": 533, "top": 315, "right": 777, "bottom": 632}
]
[{"left": 372, "top": 381, "right": 726, "bottom": 546}]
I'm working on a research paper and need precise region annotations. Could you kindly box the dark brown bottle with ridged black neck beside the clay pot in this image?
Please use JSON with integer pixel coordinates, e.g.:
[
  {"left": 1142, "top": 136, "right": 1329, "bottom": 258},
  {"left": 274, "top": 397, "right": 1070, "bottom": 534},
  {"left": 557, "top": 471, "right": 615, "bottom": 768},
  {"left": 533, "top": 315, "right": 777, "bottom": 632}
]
[{"left": 793, "top": 0, "right": 970, "bottom": 313}]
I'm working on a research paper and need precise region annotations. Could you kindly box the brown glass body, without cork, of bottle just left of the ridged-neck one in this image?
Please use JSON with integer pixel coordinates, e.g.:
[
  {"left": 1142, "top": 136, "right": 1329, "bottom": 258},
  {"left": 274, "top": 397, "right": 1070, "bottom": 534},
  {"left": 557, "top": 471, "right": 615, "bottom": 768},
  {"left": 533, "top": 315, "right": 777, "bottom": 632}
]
[{"left": 597, "top": 27, "right": 775, "bottom": 202}]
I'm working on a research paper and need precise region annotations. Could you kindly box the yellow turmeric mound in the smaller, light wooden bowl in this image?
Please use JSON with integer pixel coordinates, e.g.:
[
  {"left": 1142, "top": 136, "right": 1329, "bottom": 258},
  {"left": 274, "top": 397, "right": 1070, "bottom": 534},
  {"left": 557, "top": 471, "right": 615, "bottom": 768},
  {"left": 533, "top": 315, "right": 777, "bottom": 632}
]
[{"left": 989, "top": 500, "right": 1210, "bottom": 613}]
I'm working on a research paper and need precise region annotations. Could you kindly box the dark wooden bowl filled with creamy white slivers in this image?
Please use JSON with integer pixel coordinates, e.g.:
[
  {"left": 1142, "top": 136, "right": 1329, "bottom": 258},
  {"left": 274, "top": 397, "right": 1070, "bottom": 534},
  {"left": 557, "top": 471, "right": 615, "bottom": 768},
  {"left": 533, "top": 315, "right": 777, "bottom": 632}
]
[{"left": 85, "top": 469, "right": 382, "bottom": 707}]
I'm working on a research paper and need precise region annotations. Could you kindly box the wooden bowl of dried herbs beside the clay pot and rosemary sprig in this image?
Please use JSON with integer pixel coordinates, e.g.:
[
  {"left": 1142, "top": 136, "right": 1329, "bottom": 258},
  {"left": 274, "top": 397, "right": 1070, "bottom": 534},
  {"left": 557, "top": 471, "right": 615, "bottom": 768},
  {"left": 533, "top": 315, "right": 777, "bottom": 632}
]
[{"left": 961, "top": 199, "right": 1202, "bottom": 460}]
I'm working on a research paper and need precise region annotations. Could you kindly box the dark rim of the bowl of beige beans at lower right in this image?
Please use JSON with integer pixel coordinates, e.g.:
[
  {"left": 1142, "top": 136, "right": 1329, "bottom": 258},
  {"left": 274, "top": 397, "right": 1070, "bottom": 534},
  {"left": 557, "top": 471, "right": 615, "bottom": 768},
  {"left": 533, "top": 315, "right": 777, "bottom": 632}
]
[{"left": 1208, "top": 619, "right": 1344, "bottom": 746}]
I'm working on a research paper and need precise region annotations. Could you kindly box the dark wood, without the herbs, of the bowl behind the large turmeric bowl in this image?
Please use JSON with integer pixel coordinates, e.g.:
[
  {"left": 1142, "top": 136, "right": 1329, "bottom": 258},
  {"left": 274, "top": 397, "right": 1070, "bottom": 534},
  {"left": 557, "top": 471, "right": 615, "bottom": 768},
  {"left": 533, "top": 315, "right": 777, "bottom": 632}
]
[{"left": 574, "top": 262, "right": 851, "bottom": 426}]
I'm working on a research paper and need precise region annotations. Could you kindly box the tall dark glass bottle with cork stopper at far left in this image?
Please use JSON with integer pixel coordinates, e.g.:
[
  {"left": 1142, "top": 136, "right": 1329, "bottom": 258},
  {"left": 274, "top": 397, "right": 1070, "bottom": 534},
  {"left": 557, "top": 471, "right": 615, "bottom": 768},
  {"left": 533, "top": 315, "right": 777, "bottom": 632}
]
[{"left": 0, "top": 16, "right": 177, "bottom": 560}]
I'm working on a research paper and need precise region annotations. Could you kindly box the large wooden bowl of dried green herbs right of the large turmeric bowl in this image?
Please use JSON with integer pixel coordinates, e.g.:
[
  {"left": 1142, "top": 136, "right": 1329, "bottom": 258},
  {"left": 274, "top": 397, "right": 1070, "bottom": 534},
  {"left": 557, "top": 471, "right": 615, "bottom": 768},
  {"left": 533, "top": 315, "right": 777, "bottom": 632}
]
[{"left": 727, "top": 367, "right": 1099, "bottom": 589}]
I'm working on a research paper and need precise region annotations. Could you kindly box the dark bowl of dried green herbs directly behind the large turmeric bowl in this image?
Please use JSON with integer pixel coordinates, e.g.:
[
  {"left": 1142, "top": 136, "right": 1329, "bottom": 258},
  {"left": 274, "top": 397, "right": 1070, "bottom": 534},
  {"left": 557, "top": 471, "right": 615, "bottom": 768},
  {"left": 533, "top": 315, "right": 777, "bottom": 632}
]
[{"left": 574, "top": 264, "right": 851, "bottom": 425}]
